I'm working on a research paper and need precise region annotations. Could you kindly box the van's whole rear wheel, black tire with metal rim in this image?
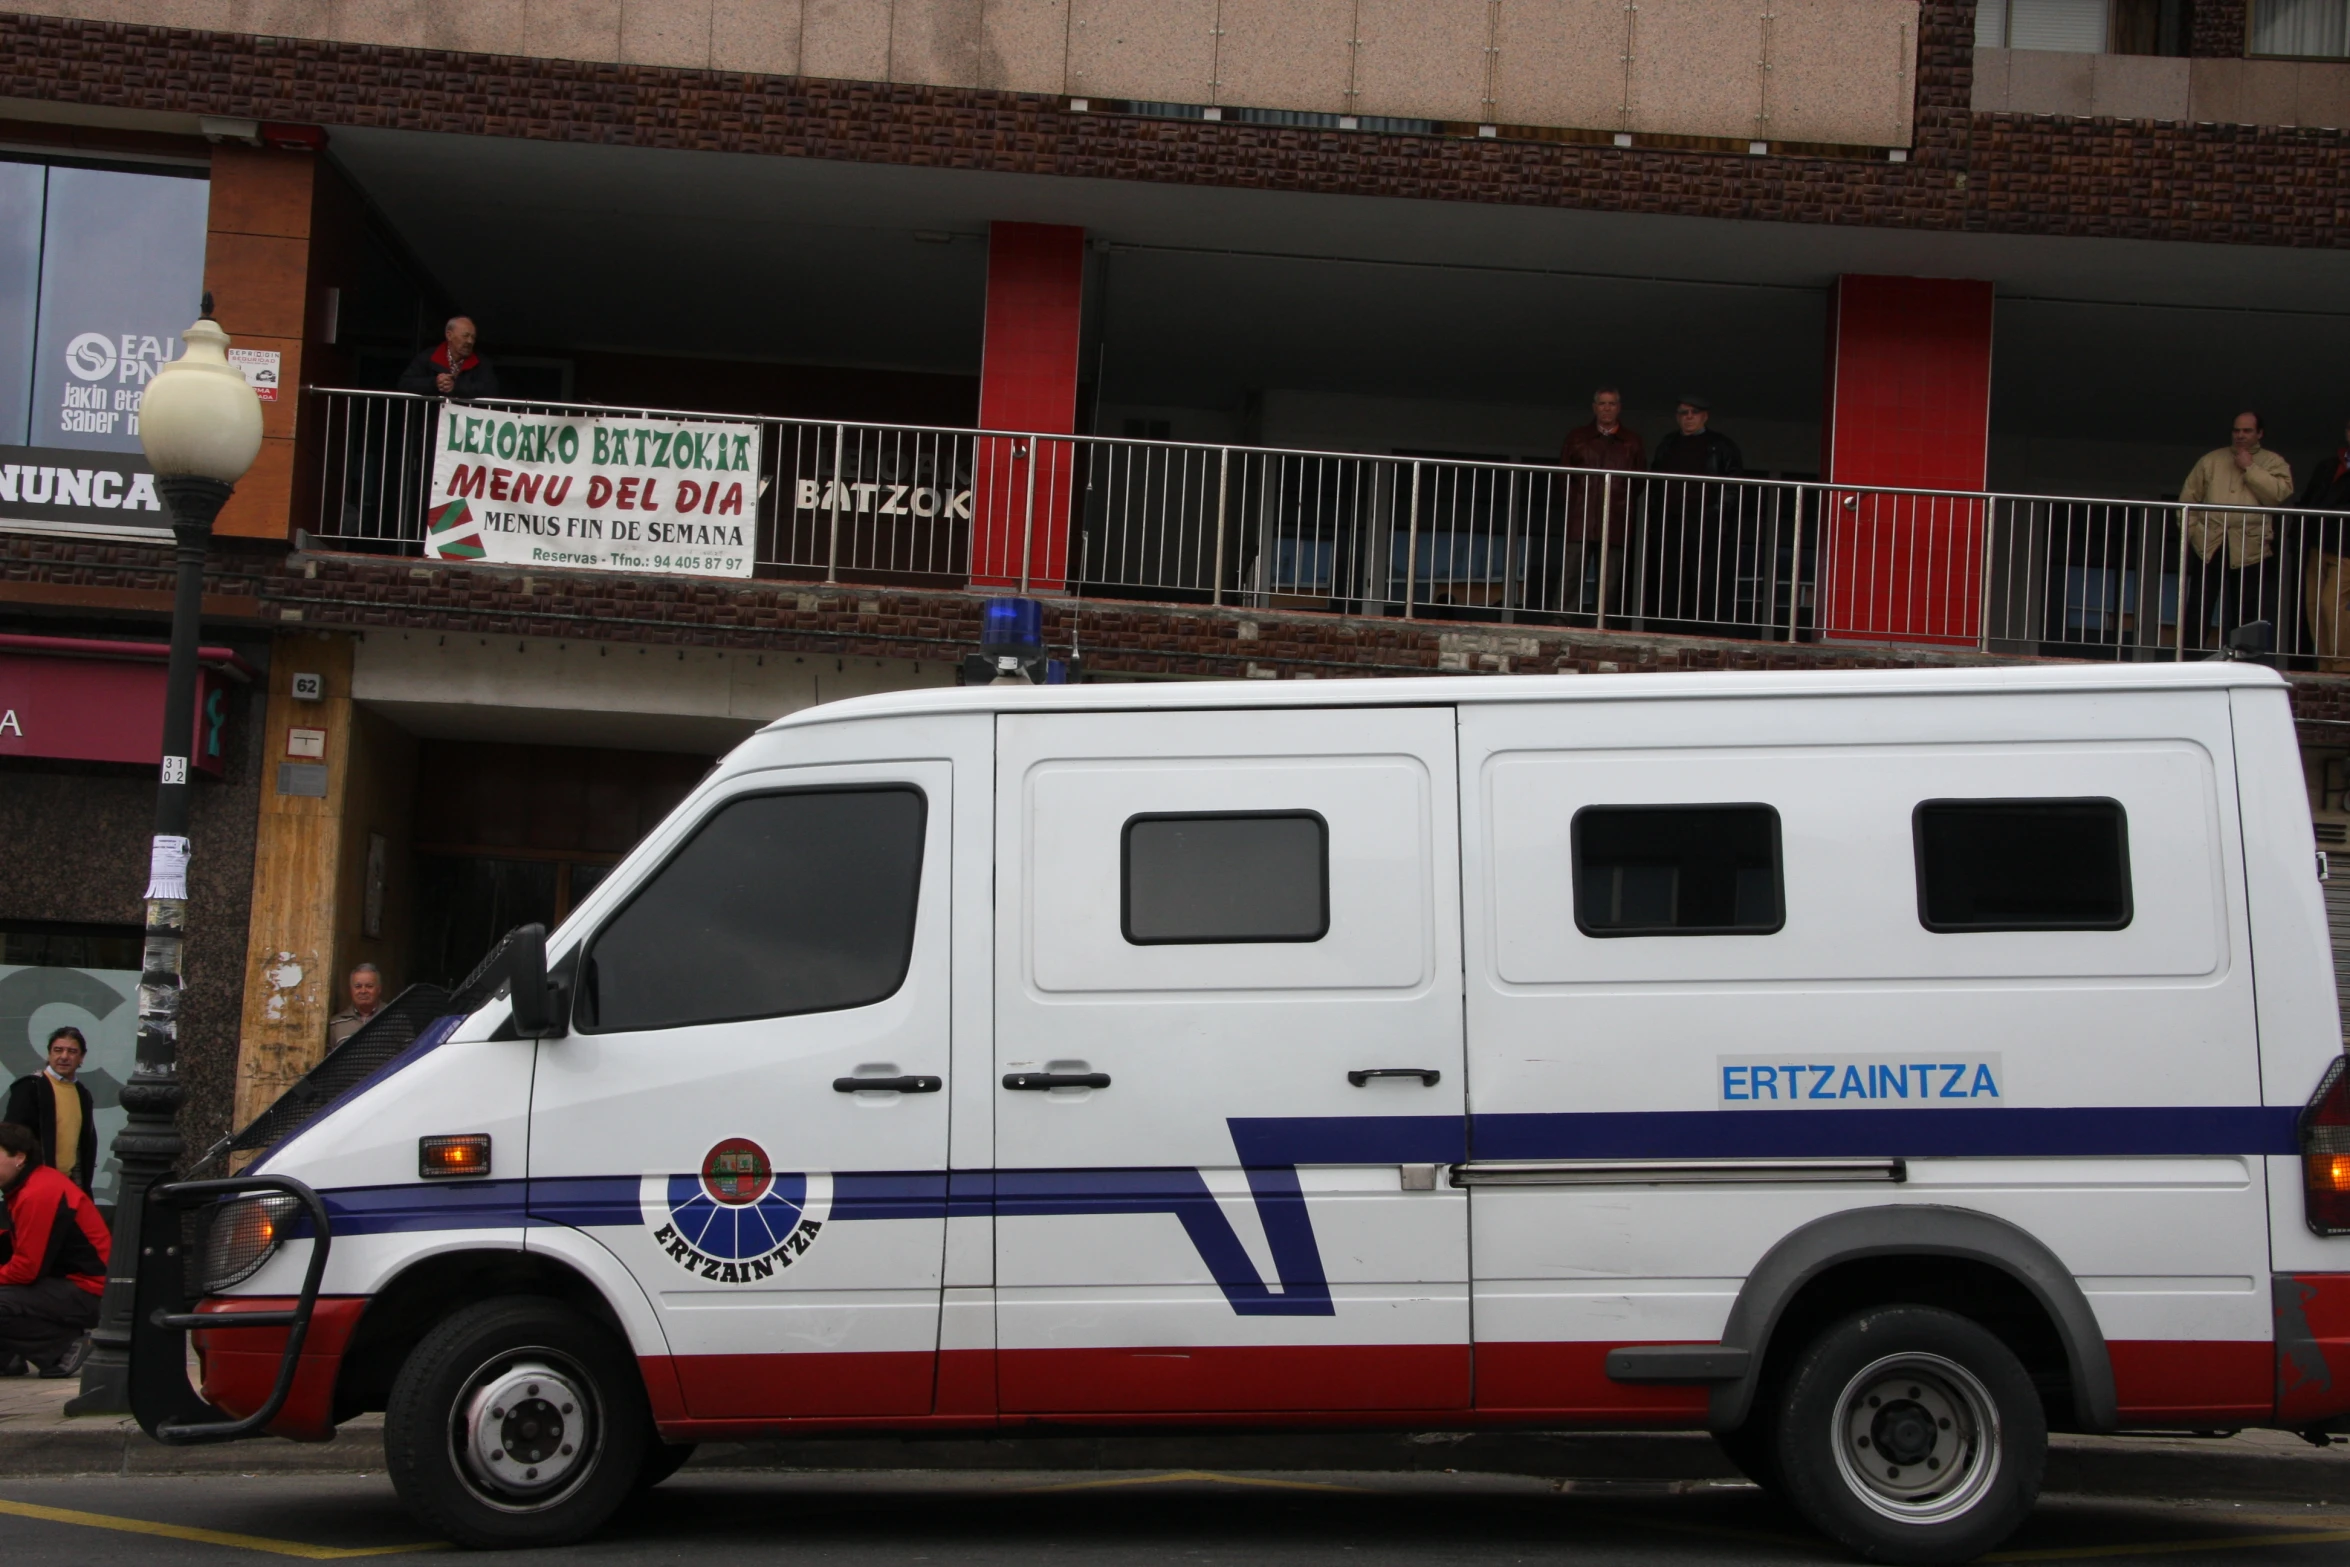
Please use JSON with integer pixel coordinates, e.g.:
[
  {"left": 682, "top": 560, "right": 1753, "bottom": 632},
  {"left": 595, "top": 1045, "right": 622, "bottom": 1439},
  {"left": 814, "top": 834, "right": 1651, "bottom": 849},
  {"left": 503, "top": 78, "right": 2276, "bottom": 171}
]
[{"left": 1777, "top": 1306, "right": 2049, "bottom": 1565}]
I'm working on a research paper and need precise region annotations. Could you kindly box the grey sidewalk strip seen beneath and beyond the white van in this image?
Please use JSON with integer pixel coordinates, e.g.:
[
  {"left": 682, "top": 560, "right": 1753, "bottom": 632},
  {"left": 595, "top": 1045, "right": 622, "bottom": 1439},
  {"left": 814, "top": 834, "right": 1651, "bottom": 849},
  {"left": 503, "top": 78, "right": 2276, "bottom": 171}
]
[{"left": 0, "top": 1377, "right": 2350, "bottom": 1504}]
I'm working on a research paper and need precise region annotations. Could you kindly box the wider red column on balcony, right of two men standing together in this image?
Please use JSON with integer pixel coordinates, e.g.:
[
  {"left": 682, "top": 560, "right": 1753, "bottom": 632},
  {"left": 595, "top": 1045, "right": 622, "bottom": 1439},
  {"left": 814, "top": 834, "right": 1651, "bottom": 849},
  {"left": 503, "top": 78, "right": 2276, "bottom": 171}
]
[{"left": 1817, "top": 277, "right": 1990, "bottom": 644}]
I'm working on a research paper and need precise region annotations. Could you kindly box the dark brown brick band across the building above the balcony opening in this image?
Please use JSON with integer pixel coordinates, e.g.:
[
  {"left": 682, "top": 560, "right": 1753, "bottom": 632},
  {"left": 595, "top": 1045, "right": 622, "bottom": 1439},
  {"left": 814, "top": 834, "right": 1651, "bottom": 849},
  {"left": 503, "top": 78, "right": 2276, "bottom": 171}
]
[{"left": 0, "top": 0, "right": 2350, "bottom": 247}]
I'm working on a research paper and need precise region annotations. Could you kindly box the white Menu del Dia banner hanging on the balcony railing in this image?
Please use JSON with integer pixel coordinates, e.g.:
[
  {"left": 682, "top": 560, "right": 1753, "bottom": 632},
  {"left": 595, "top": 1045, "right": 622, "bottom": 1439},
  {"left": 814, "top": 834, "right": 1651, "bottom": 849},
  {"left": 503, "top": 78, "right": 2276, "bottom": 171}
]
[{"left": 423, "top": 402, "right": 759, "bottom": 578}]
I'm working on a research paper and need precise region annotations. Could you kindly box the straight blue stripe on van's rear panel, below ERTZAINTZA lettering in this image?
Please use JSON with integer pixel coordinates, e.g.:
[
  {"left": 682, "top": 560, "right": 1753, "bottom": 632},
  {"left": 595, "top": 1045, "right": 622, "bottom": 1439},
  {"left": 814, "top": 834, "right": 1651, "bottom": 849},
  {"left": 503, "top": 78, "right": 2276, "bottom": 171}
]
[{"left": 1471, "top": 1104, "right": 2301, "bottom": 1158}]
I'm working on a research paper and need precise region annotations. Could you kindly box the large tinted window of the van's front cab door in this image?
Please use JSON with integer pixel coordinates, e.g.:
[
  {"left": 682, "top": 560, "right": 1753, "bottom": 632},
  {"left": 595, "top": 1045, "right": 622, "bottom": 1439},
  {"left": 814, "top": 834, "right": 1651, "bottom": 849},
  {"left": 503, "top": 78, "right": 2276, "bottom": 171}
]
[{"left": 578, "top": 787, "right": 926, "bottom": 1034}]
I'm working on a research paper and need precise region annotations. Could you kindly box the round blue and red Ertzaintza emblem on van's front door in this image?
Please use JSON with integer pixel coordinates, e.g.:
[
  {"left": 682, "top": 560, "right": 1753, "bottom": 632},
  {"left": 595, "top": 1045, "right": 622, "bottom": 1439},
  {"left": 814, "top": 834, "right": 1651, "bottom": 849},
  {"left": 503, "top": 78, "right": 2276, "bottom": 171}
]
[{"left": 639, "top": 1137, "right": 832, "bottom": 1285}]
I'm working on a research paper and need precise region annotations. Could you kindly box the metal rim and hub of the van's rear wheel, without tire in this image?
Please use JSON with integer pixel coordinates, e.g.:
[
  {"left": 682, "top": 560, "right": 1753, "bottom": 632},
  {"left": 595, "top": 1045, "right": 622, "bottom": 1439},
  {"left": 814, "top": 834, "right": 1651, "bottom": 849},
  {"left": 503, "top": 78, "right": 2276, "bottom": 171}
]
[{"left": 1835, "top": 1353, "right": 2000, "bottom": 1522}]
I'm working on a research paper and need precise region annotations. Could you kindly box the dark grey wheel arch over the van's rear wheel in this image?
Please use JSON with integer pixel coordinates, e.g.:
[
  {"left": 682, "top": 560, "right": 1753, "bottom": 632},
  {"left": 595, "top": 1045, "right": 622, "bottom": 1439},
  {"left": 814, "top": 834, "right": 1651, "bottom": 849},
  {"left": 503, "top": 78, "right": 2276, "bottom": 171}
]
[{"left": 1706, "top": 1205, "right": 2120, "bottom": 1433}]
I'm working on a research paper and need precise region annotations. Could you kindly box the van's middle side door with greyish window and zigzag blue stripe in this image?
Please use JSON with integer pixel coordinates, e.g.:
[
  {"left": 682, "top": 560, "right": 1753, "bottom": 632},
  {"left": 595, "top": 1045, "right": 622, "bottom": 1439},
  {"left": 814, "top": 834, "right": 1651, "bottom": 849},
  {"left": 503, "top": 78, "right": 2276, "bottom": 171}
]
[{"left": 994, "top": 707, "right": 1469, "bottom": 1412}]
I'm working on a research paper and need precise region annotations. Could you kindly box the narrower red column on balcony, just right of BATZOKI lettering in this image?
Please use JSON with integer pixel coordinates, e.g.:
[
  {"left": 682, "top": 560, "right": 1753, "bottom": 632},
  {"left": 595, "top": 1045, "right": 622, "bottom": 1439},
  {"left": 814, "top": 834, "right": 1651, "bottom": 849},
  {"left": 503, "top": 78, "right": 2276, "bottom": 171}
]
[{"left": 971, "top": 223, "right": 1086, "bottom": 592}]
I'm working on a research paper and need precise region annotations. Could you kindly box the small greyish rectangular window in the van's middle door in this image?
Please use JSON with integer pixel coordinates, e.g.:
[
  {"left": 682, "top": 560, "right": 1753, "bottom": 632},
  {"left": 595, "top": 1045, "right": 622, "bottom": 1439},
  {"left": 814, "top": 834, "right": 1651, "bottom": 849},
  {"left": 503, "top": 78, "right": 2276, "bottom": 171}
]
[{"left": 1119, "top": 811, "right": 1330, "bottom": 947}]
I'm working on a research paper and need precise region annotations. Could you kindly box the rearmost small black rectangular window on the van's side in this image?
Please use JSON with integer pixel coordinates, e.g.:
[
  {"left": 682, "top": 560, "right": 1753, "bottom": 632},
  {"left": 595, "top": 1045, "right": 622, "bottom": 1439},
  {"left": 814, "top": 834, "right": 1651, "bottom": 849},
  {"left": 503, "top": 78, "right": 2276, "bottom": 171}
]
[{"left": 1911, "top": 799, "right": 2131, "bottom": 930}]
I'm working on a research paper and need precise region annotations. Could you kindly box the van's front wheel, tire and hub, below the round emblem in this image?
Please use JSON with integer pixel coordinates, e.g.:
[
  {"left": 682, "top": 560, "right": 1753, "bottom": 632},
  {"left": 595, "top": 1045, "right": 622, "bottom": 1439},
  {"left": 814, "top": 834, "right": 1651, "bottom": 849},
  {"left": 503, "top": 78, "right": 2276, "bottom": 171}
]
[{"left": 383, "top": 1294, "right": 653, "bottom": 1548}]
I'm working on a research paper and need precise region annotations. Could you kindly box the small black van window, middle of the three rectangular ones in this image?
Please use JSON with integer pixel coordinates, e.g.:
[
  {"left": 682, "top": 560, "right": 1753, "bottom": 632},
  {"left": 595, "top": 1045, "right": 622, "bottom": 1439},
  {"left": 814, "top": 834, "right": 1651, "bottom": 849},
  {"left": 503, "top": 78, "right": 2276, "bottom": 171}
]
[{"left": 1572, "top": 806, "right": 1786, "bottom": 935}]
